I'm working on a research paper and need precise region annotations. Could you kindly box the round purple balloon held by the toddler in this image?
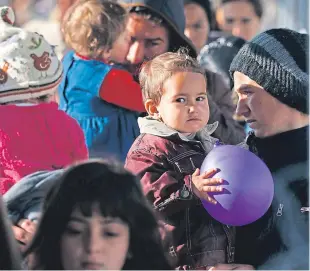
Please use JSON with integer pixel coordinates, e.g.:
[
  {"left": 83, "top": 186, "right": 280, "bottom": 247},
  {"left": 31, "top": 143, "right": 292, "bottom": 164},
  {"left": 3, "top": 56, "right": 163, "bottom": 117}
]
[{"left": 201, "top": 145, "right": 274, "bottom": 226}]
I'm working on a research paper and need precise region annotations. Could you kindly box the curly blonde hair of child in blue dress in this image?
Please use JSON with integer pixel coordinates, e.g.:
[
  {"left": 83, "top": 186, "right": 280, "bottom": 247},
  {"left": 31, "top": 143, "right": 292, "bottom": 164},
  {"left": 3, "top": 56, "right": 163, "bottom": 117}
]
[{"left": 62, "top": 0, "right": 128, "bottom": 58}]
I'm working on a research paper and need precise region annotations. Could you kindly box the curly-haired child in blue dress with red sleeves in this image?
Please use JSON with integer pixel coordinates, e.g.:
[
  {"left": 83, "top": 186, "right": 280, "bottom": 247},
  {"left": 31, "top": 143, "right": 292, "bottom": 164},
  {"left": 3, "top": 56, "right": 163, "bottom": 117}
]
[{"left": 58, "top": 0, "right": 145, "bottom": 161}]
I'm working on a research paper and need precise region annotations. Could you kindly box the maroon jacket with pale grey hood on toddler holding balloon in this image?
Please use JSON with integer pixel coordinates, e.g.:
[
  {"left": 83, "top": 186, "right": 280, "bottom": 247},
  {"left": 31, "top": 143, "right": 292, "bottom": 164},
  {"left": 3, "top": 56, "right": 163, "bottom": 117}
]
[{"left": 125, "top": 118, "right": 234, "bottom": 269}]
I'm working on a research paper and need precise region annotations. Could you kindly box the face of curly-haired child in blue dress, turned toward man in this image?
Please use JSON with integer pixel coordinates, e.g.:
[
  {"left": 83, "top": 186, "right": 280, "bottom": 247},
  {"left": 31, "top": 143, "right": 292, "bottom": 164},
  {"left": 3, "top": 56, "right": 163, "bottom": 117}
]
[{"left": 109, "top": 31, "right": 131, "bottom": 64}]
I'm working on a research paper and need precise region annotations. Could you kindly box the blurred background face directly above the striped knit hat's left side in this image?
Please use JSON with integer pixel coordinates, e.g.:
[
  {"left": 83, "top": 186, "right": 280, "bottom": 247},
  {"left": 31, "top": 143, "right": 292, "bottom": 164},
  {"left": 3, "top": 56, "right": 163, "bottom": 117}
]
[{"left": 216, "top": 0, "right": 263, "bottom": 40}]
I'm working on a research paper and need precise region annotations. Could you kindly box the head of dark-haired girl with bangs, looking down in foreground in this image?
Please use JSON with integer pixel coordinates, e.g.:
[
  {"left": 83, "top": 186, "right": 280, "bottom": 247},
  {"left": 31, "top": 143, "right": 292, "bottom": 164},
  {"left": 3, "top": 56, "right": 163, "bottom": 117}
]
[{"left": 25, "top": 161, "right": 171, "bottom": 270}]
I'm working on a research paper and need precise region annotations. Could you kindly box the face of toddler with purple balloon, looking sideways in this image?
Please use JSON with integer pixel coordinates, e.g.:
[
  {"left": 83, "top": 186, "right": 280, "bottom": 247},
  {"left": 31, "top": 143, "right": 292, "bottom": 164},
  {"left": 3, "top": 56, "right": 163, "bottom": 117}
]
[{"left": 157, "top": 72, "right": 209, "bottom": 133}]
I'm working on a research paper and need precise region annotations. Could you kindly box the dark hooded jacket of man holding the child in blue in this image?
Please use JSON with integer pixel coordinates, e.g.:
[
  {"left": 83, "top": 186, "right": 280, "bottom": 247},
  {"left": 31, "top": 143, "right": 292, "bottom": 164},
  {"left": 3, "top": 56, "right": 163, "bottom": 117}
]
[{"left": 119, "top": 0, "right": 245, "bottom": 144}]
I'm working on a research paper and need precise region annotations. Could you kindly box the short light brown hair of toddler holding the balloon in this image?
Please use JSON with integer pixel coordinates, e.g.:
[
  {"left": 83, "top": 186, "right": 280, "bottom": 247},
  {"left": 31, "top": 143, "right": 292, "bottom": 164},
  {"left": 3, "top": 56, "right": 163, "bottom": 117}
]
[{"left": 139, "top": 48, "right": 205, "bottom": 103}]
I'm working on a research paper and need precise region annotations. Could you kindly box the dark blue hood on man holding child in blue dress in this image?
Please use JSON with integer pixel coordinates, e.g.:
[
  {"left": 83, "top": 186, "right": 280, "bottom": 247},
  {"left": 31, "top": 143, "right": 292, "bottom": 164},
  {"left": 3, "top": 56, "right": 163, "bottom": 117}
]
[{"left": 120, "top": 0, "right": 197, "bottom": 58}]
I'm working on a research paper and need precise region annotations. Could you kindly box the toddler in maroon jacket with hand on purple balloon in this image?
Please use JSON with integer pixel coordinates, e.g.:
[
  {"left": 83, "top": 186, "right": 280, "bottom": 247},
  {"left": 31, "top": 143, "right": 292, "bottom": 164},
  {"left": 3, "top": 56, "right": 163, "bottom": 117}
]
[{"left": 125, "top": 50, "right": 234, "bottom": 269}]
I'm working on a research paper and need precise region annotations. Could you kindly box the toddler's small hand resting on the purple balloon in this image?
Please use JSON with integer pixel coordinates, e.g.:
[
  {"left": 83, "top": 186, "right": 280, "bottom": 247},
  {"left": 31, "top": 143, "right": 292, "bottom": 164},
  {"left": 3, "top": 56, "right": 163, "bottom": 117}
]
[{"left": 192, "top": 168, "right": 223, "bottom": 204}]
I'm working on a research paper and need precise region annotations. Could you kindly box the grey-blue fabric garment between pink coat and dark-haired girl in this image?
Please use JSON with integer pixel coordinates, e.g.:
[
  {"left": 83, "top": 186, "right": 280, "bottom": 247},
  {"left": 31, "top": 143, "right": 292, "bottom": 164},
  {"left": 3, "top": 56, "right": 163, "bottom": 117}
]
[{"left": 3, "top": 169, "right": 64, "bottom": 224}]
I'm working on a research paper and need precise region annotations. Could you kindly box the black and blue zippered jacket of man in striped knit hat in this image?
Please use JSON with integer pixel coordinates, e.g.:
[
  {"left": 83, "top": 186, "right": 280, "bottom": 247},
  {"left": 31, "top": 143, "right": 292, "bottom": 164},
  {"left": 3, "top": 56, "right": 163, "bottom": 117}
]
[{"left": 236, "top": 126, "right": 309, "bottom": 270}]
